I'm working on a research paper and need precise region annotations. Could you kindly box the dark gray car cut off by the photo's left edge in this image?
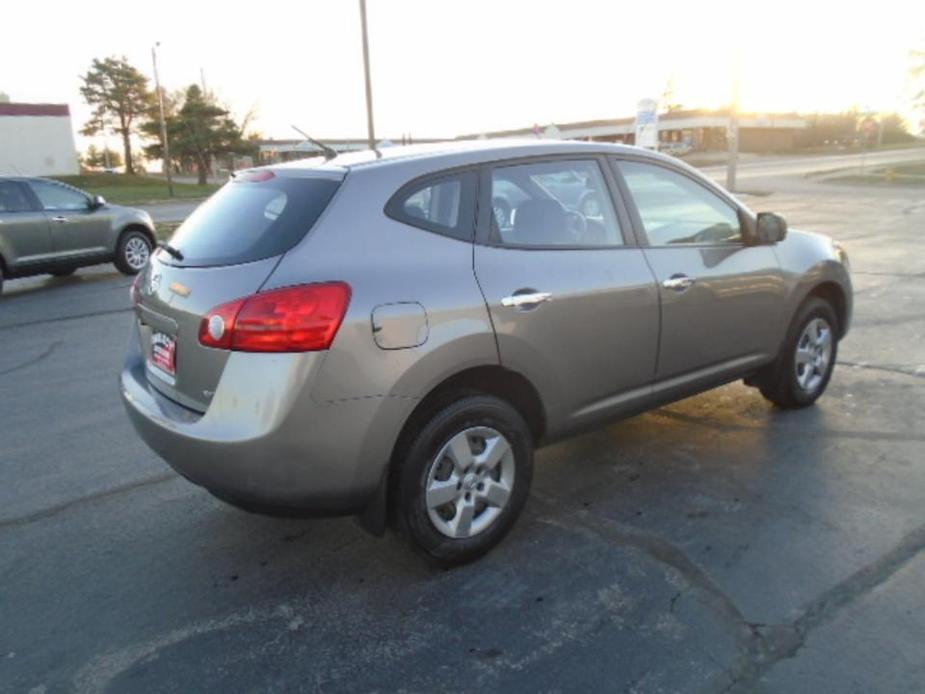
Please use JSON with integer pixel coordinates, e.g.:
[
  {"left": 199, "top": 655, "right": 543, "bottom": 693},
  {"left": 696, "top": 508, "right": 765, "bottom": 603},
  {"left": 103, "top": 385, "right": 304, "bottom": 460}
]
[{"left": 0, "top": 177, "right": 156, "bottom": 291}]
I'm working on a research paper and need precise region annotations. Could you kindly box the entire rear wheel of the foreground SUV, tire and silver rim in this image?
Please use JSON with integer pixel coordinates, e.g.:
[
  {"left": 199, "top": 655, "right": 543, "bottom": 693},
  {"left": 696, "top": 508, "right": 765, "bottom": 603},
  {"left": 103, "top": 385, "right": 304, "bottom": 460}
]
[{"left": 394, "top": 395, "right": 533, "bottom": 564}]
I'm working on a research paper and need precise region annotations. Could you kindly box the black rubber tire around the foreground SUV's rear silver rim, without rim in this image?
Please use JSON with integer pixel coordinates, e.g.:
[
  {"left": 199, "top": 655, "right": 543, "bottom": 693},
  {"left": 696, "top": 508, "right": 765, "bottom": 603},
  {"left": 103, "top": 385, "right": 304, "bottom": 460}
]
[{"left": 392, "top": 395, "right": 533, "bottom": 566}]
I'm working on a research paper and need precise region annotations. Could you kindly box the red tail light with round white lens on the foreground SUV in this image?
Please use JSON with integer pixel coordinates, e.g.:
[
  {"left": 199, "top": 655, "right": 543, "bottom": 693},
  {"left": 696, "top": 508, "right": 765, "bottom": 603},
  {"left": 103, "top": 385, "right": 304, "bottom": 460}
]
[{"left": 199, "top": 282, "right": 350, "bottom": 352}]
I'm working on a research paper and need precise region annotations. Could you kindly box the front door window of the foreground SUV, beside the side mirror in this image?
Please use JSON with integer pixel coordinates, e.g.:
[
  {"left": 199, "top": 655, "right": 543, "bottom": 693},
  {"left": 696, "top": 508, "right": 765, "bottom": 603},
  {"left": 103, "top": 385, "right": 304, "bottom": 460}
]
[{"left": 619, "top": 161, "right": 742, "bottom": 246}]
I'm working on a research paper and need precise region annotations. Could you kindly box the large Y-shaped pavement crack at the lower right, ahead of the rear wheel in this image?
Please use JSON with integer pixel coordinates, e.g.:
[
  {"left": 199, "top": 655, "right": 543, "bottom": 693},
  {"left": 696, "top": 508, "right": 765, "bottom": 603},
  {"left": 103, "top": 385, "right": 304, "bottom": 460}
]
[{"left": 531, "top": 491, "right": 925, "bottom": 694}]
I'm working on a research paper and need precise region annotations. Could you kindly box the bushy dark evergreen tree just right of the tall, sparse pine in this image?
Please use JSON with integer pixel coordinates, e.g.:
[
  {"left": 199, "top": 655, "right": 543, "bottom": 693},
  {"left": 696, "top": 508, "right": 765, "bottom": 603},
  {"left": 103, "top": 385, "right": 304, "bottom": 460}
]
[{"left": 144, "top": 84, "right": 247, "bottom": 185}]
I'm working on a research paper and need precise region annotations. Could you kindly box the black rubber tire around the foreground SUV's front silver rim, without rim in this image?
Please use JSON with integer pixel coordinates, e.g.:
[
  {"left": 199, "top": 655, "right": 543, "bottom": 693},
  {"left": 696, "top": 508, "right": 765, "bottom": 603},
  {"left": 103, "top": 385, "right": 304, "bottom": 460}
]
[{"left": 756, "top": 297, "right": 839, "bottom": 408}]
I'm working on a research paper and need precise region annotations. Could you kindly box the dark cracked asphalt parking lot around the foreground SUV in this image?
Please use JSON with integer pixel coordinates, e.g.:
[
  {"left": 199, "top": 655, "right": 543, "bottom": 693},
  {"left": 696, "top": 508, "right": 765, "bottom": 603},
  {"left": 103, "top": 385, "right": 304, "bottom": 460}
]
[{"left": 0, "top": 181, "right": 925, "bottom": 693}]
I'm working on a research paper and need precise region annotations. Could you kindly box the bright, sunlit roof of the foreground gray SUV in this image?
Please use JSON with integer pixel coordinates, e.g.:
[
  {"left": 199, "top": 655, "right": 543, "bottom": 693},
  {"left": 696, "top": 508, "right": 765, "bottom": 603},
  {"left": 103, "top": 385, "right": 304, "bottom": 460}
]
[{"left": 273, "top": 139, "right": 667, "bottom": 171}]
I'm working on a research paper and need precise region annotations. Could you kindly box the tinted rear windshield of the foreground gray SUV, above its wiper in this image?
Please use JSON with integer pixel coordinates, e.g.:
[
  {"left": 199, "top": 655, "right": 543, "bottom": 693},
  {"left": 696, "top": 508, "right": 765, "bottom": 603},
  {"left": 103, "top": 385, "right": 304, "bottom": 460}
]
[{"left": 160, "top": 172, "right": 340, "bottom": 267}]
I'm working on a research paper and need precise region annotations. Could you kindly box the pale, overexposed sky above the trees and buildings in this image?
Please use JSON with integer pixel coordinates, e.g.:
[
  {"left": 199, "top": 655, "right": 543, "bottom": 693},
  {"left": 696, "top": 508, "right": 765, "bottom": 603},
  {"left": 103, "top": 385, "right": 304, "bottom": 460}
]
[{"left": 0, "top": 0, "right": 925, "bottom": 147}]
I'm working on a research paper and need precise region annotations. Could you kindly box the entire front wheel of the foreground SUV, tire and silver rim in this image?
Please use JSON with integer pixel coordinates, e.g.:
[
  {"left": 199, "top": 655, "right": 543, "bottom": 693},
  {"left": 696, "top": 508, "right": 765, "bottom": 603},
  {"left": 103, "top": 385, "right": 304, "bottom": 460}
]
[{"left": 758, "top": 297, "right": 838, "bottom": 407}]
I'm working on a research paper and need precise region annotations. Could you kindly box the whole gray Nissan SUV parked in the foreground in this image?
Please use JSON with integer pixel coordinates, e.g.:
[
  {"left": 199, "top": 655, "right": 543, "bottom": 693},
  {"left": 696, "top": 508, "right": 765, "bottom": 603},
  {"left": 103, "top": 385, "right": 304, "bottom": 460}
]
[{"left": 121, "top": 141, "right": 852, "bottom": 563}]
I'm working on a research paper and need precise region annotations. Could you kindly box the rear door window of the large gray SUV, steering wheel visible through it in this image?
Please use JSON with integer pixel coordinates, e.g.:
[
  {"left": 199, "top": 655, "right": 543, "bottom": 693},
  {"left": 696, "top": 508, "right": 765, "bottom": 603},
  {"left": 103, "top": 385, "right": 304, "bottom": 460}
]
[{"left": 491, "top": 160, "right": 623, "bottom": 247}]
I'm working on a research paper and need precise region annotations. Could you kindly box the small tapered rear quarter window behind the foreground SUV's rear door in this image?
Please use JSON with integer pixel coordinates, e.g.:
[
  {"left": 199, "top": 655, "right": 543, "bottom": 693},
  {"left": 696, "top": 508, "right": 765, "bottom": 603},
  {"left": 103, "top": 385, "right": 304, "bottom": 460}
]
[{"left": 385, "top": 171, "right": 476, "bottom": 241}]
